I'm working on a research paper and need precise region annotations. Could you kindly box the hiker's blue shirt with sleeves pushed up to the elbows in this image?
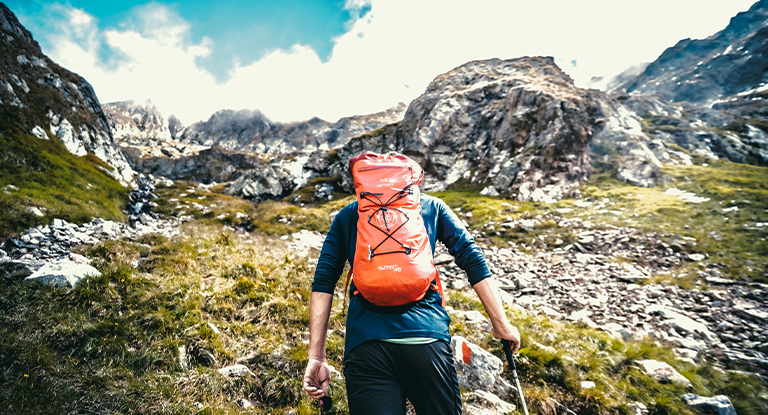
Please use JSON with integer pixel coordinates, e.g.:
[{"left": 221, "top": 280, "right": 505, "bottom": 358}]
[{"left": 312, "top": 194, "right": 491, "bottom": 355}]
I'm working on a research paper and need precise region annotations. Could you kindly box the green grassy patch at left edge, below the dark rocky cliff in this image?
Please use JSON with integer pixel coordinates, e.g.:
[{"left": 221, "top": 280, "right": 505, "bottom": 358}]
[{"left": 0, "top": 130, "right": 129, "bottom": 240}]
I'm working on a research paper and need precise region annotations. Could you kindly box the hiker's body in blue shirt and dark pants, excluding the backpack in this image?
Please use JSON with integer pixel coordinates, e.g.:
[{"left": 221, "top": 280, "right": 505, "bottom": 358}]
[{"left": 304, "top": 156, "right": 519, "bottom": 415}]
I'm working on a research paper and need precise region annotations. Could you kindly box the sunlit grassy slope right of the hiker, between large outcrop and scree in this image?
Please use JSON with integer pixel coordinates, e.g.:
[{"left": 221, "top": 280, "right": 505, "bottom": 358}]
[{"left": 435, "top": 160, "right": 768, "bottom": 283}]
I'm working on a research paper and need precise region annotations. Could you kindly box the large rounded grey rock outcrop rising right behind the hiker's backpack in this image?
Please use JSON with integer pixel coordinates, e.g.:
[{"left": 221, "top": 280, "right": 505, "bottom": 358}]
[{"left": 314, "top": 57, "right": 670, "bottom": 201}]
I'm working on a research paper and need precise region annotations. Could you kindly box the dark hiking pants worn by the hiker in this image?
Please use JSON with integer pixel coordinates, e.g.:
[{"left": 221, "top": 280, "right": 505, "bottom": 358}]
[{"left": 344, "top": 340, "right": 461, "bottom": 415}]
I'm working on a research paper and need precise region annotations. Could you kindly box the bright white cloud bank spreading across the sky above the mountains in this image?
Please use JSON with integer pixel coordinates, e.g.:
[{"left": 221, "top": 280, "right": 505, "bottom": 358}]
[{"left": 39, "top": 0, "right": 751, "bottom": 123}]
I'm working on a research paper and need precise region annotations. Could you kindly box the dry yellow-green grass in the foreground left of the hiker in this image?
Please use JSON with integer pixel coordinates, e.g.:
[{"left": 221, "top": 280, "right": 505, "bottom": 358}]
[{"left": 0, "top": 223, "right": 345, "bottom": 414}]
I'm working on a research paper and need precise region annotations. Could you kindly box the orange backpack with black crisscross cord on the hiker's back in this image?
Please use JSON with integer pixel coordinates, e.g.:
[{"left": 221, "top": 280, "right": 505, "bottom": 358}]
[{"left": 345, "top": 152, "right": 443, "bottom": 307}]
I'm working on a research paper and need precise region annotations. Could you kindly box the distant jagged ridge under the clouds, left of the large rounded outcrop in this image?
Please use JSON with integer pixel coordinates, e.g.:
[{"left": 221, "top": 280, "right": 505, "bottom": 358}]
[{"left": 177, "top": 103, "right": 405, "bottom": 154}]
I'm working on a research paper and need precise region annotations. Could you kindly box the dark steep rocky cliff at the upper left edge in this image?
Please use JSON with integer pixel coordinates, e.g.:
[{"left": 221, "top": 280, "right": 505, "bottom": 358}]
[{"left": 0, "top": 3, "right": 133, "bottom": 184}]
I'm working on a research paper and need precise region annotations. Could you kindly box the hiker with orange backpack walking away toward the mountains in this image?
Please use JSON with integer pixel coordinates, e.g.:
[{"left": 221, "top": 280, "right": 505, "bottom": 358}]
[{"left": 304, "top": 152, "right": 520, "bottom": 415}]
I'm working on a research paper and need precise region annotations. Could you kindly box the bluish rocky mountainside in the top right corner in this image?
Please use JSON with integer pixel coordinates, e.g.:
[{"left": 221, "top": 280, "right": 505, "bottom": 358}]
[{"left": 621, "top": 0, "right": 768, "bottom": 104}]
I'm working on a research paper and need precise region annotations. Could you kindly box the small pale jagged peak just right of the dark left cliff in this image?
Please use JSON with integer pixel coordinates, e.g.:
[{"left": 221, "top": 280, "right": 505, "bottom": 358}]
[{"left": 102, "top": 101, "right": 171, "bottom": 146}]
